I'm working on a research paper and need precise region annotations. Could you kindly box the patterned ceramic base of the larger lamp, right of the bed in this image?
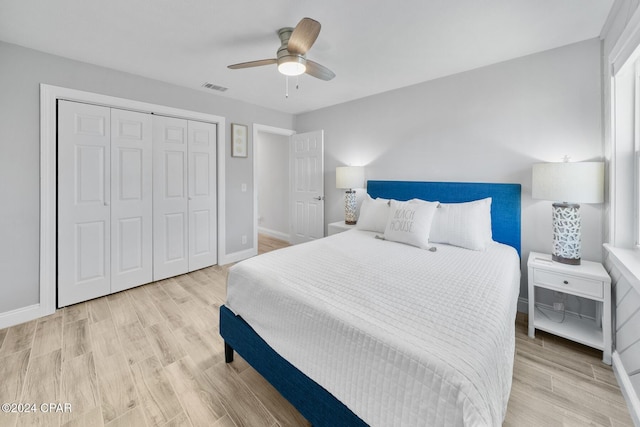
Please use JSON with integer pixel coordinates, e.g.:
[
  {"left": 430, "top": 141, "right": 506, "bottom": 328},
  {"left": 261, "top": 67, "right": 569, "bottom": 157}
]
[{"left": 552, "top": 203, "right": 581, "bottom": 265}]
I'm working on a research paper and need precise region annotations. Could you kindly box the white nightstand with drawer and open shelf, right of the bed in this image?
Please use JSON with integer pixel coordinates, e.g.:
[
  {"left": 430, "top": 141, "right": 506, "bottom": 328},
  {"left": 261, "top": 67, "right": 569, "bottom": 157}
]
[{"left": 527, "top": 252, "right": 611, "bottom": 365}]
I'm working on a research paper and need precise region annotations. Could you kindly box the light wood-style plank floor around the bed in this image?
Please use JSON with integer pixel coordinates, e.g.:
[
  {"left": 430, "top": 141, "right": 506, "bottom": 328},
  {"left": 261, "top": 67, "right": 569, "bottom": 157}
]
[{"left": 0, "top": 237, "right": 632, "bottom": 427}]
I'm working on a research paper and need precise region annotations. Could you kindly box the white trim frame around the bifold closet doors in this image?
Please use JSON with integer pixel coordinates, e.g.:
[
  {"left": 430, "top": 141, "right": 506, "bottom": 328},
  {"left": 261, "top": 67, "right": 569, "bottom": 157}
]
[{"left": 38, "top": 84, "right": 226, "bottom": 321}]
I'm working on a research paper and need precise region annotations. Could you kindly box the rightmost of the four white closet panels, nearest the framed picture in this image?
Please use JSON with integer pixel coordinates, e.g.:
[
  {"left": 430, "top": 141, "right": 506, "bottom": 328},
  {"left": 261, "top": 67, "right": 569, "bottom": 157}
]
[{"left": 187, "top": 121, "right": 218, "bottom": 271}]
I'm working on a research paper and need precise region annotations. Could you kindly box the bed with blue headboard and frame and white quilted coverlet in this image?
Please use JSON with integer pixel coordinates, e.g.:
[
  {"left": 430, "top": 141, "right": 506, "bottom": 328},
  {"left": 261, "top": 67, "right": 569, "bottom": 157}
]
[{"left": 220, "top": 181, "right": 520, "bottom": 426}]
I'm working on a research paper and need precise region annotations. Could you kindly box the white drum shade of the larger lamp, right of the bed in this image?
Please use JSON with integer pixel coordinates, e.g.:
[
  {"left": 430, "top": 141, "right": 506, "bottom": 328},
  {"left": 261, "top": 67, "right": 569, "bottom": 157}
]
[{"left": 531, "top": 162, "right": 604, "bottom": 203}]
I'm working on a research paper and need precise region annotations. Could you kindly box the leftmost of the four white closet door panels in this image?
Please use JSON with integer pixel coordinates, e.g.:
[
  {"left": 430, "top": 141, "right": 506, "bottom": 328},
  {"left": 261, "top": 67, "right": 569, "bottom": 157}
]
[{"left": 58, "top": 101, "right": 111, "bottom": 307}]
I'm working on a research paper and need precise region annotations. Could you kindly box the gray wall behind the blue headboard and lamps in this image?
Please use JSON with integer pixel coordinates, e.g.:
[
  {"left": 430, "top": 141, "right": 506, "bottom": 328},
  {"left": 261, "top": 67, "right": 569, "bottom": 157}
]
[{"left": 295, "top": 39, "right": 603, "bottom": 308}]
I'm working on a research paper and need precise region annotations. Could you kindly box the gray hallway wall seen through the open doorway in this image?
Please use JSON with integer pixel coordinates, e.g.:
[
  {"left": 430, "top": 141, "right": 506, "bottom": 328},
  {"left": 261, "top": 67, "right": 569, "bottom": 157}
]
[{"left": 255, "top": 132, "right": 289, "bottom": 239}]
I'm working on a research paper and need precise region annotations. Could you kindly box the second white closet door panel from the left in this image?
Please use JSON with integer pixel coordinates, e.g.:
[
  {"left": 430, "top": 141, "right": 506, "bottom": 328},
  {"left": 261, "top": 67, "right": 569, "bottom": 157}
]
[{"left": 111, "top": 109, "right": 153, "bottom": 292}]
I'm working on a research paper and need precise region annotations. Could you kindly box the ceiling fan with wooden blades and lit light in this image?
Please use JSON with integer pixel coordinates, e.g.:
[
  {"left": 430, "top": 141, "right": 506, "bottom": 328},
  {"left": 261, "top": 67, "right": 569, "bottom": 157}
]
[{"left": 228, "top": 18, "right": 336, "bottom": 80}]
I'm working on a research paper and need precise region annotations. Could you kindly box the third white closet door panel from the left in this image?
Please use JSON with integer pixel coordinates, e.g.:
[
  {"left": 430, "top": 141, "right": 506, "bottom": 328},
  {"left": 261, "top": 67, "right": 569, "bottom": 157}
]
[{"left": 153, "top": 116, "right": 189, "bottom": 280}]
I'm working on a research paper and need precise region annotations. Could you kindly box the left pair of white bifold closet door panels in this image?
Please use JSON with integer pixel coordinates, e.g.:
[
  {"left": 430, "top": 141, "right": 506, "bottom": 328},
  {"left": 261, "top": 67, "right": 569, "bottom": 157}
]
[{"left": 58, "top": 101, "right": 153, "bottom": 307}]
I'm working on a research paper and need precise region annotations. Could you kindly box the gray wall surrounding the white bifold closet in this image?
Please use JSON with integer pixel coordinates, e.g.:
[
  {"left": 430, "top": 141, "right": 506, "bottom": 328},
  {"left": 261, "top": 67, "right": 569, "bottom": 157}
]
[{"left": 0, "top": 42, "right": 293, "bottom": 313}]
